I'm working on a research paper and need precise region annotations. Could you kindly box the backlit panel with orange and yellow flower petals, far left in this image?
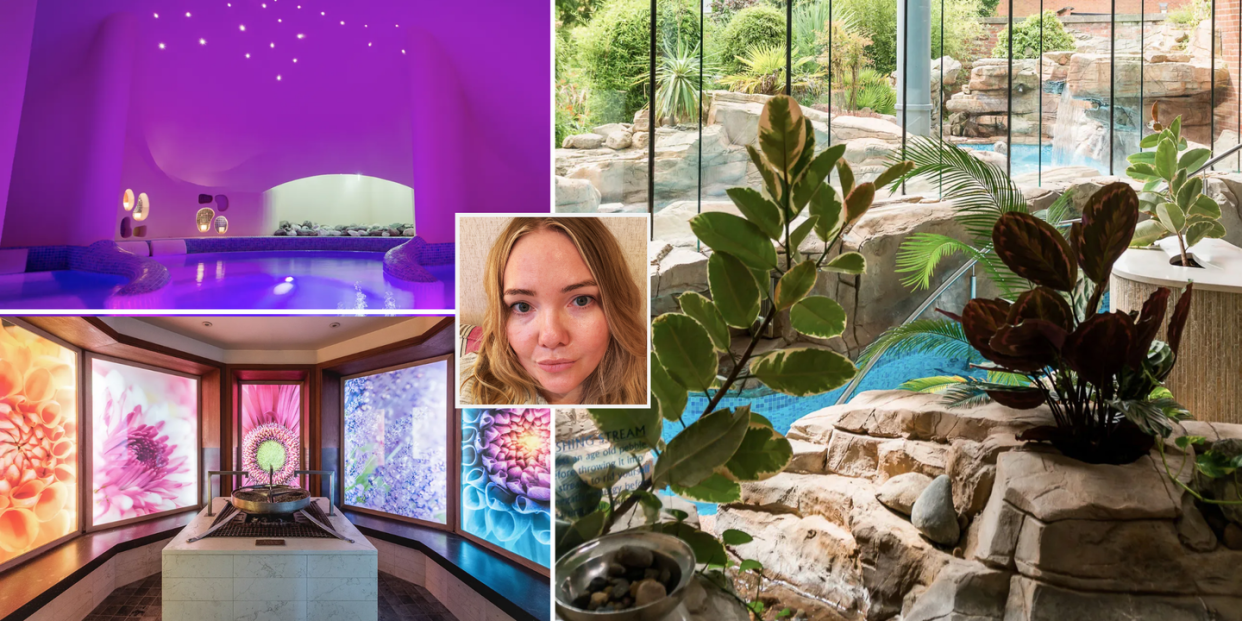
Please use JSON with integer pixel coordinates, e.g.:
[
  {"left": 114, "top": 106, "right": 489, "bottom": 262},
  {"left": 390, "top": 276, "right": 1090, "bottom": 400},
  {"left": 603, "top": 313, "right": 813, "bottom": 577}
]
[{"left": 0, "top": 322, "right": 78, "bottom": 564}]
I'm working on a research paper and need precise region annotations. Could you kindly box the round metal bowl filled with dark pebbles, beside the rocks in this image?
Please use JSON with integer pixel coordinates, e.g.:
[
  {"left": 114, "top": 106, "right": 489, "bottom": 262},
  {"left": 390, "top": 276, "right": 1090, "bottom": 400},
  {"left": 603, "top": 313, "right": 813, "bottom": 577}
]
[{"left": 556, "top": 532, "right": 694, "bottom": 621}]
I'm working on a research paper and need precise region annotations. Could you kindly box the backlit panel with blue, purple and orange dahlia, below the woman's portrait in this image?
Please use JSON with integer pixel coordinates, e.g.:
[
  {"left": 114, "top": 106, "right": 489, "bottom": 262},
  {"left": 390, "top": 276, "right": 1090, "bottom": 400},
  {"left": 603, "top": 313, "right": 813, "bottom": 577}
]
[{"left": 461, "top": 410, "right": 551, "bottom": 566}]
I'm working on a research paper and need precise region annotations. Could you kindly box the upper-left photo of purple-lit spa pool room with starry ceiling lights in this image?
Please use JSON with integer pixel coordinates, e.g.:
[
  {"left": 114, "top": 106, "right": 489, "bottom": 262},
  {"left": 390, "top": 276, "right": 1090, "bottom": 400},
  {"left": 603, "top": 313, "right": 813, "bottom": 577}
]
[{"left": 0, "top": 0, "right": 551, "bottom": 311}]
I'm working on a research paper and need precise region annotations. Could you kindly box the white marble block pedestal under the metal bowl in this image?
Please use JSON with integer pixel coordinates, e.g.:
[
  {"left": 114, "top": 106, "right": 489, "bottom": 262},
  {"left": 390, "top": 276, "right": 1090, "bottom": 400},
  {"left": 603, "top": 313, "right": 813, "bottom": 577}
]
[{"left": 163, "top": 498, "right": 379, "bottom": 621}]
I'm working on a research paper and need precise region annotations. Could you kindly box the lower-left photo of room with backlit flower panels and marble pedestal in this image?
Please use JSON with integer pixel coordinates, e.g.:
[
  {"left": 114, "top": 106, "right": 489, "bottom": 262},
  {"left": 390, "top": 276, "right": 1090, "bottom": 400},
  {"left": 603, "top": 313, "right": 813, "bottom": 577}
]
[{"left": 0, "top": 315, "right": 551, "bottom": 621}]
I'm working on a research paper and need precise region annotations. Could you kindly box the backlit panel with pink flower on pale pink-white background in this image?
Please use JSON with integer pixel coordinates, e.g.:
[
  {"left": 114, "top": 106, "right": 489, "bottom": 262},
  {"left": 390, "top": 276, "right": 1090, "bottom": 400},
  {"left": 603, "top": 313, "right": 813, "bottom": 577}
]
[{"left": 91, "top": 359, "right": 199, "bottom": 527}]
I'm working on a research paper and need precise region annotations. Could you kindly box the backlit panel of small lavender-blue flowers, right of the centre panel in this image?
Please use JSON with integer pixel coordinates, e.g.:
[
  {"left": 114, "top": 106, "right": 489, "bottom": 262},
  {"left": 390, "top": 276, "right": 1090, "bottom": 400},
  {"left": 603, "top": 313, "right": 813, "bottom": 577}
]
[{"left": 345, "top": 360, "right": 448, "bottom": 524}]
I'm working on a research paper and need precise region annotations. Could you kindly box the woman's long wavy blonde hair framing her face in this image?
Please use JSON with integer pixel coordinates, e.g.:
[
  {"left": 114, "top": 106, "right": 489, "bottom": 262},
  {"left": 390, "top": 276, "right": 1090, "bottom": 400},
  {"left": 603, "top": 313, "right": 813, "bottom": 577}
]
[{"left": 461, "top": 217, "right": 647, "bottom": 405}]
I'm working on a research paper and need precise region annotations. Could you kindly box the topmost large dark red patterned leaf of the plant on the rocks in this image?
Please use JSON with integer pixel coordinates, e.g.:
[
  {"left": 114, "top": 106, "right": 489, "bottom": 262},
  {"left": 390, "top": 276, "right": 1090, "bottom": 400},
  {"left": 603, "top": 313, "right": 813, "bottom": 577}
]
[{"left": 1071, "top": 181, "right": 1139, "bottom": 284}]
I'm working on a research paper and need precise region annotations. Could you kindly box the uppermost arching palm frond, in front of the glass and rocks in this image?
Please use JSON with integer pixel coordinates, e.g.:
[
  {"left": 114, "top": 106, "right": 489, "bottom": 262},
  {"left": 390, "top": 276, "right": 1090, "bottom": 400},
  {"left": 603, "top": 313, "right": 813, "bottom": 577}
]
[{"left": 889, "top": 137, "right": 1028, "bottom": 246}]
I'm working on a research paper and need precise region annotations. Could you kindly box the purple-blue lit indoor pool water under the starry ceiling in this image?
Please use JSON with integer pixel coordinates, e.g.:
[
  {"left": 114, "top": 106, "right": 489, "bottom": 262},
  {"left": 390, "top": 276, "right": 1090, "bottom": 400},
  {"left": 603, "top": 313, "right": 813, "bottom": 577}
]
[{"left": 0, "top": 251, "right": 456, "bottom": 311}]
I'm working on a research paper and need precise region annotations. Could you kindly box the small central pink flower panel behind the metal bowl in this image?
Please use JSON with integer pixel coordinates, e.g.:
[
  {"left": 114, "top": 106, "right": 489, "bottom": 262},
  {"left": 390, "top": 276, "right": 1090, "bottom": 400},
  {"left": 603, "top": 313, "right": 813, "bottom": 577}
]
[{"left": 241, "top": 384, "right": 302, "bottom": 486}]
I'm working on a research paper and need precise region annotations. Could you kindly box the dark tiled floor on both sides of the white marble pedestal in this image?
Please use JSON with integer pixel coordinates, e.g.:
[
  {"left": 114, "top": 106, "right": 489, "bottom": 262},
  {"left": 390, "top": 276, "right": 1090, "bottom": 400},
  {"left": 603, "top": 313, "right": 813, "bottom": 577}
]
[{"left": 86, "top": 571, "right": 457, "bottom": 621}]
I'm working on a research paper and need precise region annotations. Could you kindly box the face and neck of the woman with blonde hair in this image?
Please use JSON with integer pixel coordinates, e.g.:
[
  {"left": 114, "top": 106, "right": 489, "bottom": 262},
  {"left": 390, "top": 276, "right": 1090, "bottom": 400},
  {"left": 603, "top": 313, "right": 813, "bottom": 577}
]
[{"left": 503, "top": 229, "right": 609, "bottom": 404}]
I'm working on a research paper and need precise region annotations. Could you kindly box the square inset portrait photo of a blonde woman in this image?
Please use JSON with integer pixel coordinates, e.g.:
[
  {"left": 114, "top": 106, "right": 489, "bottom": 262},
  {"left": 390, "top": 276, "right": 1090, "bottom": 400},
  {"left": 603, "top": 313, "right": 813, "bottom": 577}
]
[{"left": 456, "top": 214, "right": 651, "bottom": 407}]
